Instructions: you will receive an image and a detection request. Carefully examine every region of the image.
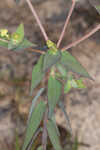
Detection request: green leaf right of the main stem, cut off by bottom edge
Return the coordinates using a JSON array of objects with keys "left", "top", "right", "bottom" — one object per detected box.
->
[{"left": 47, "top": 120, "right": 62, "bottom": 150}]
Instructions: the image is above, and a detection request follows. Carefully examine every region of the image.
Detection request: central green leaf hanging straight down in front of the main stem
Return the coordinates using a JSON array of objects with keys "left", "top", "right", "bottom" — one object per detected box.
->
[{"left": 48, "top": 76, "right": 61, "bottom": 118}]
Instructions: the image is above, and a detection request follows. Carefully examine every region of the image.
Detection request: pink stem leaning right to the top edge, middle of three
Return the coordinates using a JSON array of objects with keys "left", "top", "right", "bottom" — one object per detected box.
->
[{"left": 57, "top": 0, "right": 76, "bottom": 48}]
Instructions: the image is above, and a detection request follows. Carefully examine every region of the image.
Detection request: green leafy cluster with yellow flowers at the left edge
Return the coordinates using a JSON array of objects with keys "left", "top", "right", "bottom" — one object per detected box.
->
[{"left": 0, "top": 24, "right": 36, "bottom": 50}]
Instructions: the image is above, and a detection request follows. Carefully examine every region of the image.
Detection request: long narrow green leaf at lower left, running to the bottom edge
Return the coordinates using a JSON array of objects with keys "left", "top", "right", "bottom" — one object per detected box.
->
[{"left": 22, "top": 101, "right": 46, "bottom": 150}]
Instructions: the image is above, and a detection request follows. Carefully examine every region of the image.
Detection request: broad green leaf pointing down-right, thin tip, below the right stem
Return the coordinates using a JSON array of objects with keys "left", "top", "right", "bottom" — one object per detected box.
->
[{"left": 61, "top": 51, "right": 91, "bottom": 78}]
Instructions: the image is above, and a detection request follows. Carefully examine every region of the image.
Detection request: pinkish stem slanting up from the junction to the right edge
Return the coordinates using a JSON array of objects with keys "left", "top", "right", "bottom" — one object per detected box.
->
[{"left": 61, "top": 24, "right": 100, "bottom": 51}]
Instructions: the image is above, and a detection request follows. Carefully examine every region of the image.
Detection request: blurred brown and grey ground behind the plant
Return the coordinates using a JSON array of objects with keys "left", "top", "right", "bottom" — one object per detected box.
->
[{"left": 0, "top": 0, "right": 100, "bottom": 150}]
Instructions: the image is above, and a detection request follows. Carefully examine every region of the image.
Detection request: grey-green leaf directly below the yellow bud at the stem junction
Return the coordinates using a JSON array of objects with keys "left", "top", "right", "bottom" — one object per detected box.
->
[{"left": 43, "top": 50, "right": 61, "bottom": 71}]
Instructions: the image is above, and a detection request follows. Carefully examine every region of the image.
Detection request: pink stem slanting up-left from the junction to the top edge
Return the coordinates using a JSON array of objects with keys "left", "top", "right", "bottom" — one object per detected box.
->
[{"left": 26, "top": 0, "right": 48, "bottom": 41}]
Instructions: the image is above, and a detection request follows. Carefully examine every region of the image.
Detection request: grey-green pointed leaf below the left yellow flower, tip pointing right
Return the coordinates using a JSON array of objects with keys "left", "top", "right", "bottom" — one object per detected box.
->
[{"left": 13, "top": 39, "right": 36, "bottom": 51}]
